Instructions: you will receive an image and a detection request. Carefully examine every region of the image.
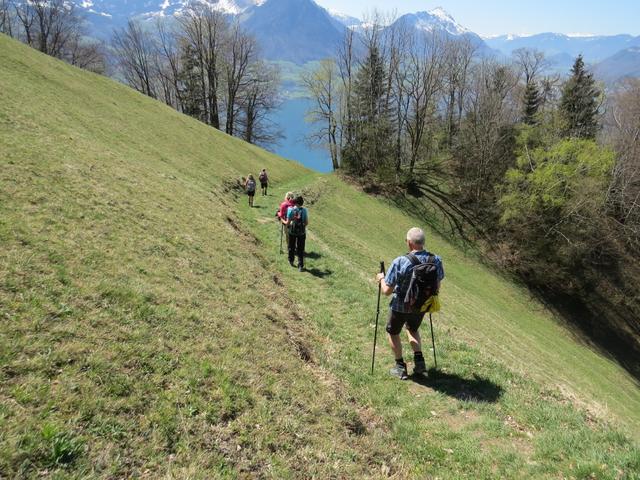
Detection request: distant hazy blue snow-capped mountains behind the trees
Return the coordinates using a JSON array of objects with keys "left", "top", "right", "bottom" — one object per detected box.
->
[{"left": 77, "top": 0, "right": 640, "bottom": 82}]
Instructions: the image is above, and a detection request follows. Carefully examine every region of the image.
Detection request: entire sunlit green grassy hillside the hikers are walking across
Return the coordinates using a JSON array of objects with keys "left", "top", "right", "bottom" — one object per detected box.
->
[{"left": 0, "top": 36, "right": 640, "bottom": 479}]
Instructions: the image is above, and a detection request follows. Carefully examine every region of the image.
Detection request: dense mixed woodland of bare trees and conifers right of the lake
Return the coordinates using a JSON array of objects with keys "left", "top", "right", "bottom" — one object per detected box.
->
[{"left": 304, "top": 18, "right": 640, "bottom": 376}]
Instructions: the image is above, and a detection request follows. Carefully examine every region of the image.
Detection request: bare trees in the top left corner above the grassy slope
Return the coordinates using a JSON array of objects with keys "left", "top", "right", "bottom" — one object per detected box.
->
[{"left": 0, "top": 0, "right": 106, "bottom": 74}]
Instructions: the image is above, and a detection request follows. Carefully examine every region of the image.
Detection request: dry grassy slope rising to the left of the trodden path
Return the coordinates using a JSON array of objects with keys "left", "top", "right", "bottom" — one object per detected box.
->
[{"left": 0, "top": 32, "right": 384, "bottom": 478}]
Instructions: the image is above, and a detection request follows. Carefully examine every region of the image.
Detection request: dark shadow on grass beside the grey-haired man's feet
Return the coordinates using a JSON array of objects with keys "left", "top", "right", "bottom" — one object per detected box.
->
[{"left": 409, "top": 369, "right": 502, "bottom": 403}]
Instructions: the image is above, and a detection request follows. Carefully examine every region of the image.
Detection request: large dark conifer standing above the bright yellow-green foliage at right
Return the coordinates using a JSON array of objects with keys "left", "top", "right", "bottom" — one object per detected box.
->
[{"left": 560, "top": 55, "right": 600, "bottom": 139}]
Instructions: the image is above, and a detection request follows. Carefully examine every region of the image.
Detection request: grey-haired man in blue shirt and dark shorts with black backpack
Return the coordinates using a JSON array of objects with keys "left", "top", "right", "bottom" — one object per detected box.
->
[{"left": 376, "top": 228, "right": 444, "bottom": 380}]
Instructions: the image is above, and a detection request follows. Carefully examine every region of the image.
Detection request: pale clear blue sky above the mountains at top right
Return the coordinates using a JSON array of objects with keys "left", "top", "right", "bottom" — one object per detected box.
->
[{"left": 316, "top": 0, "right": 640, "bottom": 35}]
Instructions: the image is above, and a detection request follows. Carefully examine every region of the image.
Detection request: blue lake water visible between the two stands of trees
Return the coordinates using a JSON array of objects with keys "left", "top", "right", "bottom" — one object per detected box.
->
[{"left": 273, "top": 98, "right": 332, "bottom": 173}]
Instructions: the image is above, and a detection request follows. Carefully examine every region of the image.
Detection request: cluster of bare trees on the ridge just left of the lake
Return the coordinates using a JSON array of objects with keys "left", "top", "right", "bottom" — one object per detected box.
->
[{"left": 111, "top": 2, "right": 280, "bottom": 146}]
